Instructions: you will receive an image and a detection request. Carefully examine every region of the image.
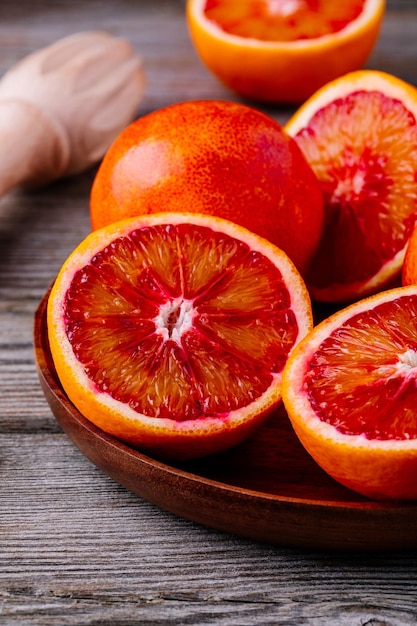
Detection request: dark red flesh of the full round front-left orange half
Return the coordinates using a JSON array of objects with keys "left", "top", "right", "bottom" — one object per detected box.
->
[{"left": 64, "top": 224, "right": 298, "bottom": 420}]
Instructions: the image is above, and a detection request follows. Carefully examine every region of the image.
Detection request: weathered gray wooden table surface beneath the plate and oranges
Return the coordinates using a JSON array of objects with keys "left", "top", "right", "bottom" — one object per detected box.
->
[{"left": 0, "top": 0, "right": 417, "bottom": 626}]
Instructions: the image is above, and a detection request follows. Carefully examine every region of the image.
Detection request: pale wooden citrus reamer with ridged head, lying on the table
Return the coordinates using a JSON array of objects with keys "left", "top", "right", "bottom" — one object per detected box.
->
[{"left": 0, "top": 31, "right": 145, "bottom": 196}]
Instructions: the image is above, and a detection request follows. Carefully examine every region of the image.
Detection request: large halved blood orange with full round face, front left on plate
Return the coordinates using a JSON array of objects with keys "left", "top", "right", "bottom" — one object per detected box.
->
[{"left": 48, "top": 213, "right": 312, "bottom": 458}]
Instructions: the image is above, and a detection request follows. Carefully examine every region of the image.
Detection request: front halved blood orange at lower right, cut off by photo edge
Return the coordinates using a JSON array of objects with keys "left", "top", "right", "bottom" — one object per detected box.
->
[{"left": 282, "top": 286, "right": 417, "bottom": 500}]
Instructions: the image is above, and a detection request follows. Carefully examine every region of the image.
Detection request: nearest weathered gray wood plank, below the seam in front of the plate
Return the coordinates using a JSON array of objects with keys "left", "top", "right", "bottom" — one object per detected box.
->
[{"left": 0, "top": 434, "right": 417, "bottom": 625}]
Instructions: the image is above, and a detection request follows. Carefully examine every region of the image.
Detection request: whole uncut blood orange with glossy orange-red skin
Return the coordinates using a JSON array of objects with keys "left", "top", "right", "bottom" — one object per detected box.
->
[{"left": 90, "top": 101, "right": 323, "bottom": 271}]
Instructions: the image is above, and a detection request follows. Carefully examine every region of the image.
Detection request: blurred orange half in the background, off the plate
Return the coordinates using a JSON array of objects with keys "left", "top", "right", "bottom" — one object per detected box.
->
[{"left": 187, "top": 0, "right": 385, "bottom": 102}]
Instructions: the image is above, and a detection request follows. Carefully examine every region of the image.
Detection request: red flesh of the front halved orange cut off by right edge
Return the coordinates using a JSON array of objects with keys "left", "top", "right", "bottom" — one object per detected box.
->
[{"left": 305, "top": 295, "right": 417, "bottom": 440}]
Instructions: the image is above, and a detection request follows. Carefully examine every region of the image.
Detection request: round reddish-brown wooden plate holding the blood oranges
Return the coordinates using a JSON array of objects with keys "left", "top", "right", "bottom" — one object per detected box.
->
[{"left": 34, "top": 294, "right": 417, "bottom": 551}]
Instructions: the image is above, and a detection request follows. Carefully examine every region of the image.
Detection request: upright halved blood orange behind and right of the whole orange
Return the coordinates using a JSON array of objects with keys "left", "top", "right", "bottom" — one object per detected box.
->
[{"left": 286, "top": 70, "right": 417, "bottom": 302}]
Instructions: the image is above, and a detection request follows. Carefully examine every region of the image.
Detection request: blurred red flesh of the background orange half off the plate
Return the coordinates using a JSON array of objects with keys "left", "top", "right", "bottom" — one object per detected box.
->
[{"left": 204, "top": 0, "right": 365, "bottom": 41}]
